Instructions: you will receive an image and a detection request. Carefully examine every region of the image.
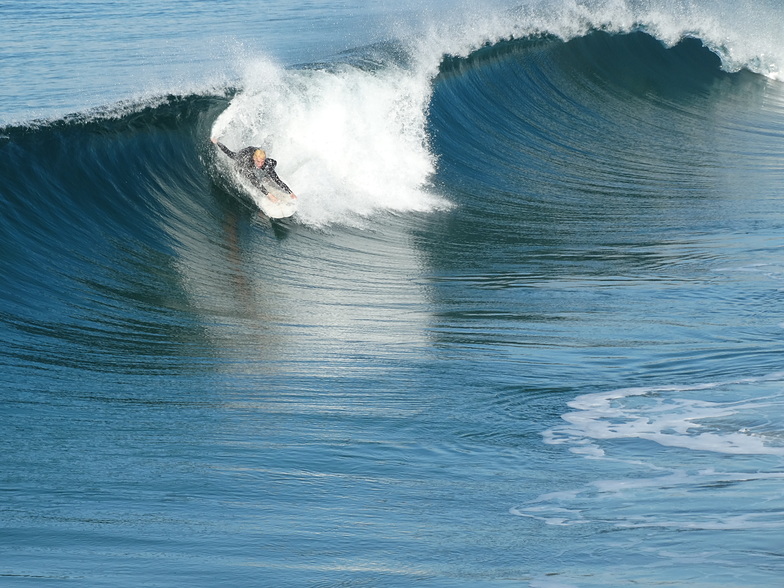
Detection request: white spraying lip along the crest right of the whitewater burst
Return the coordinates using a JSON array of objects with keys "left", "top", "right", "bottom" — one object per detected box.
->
[{"left": 415, "top": 0, "right": 784, "bottom": 80}]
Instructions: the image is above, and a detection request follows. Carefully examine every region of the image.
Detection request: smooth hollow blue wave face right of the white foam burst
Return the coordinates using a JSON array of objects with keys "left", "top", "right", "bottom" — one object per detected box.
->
[{"left": 431, "top": 32, "right": 778, "bottom": 207}]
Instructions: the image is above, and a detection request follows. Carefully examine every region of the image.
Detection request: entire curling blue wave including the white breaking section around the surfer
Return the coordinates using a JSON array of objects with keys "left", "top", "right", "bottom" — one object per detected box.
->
[{"left": 0, "top": 18, "right": 784, "bottom": 374}]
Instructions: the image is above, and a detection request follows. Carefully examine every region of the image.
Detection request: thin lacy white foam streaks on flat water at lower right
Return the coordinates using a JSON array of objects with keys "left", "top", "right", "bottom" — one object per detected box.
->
[{"left": 510, "top": 373, "right": 784, "bottom": 531}]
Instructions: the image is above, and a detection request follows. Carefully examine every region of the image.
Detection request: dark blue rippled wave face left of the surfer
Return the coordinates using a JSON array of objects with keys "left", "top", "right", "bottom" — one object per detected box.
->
[{"left": 0, "top": 96, "right": 230, "bottom": 371}]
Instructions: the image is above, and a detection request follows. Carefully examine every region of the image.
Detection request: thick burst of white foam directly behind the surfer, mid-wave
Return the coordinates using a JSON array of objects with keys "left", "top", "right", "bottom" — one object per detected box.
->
[{"left": 213, "top": 55, "right": 447, "bottom": 225}]
